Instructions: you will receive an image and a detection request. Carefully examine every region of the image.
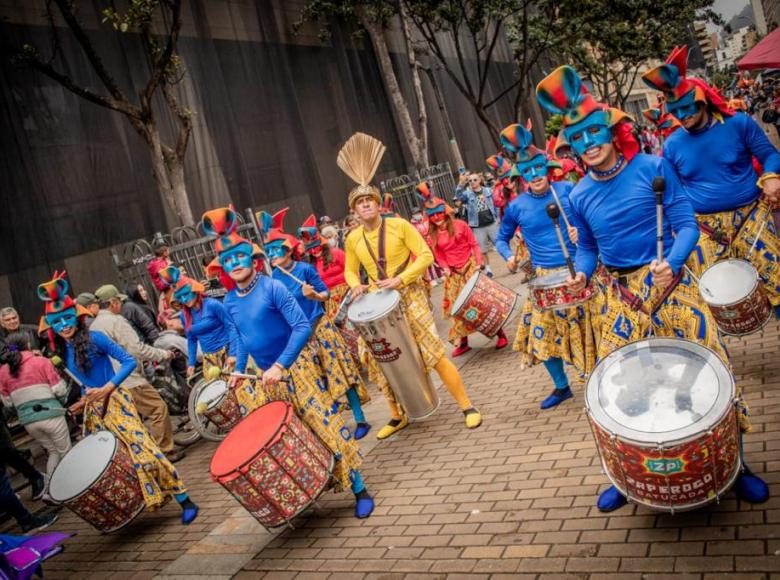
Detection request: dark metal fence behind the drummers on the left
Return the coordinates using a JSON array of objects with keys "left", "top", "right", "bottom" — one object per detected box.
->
[{"left": 109, "top": 210, "right": 262, "bottom": 310}]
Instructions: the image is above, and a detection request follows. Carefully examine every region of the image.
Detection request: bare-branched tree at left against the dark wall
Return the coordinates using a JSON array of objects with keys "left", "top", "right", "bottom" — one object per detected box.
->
[{"left": 14, "top": 0, "right": 194, "bottom": 225}]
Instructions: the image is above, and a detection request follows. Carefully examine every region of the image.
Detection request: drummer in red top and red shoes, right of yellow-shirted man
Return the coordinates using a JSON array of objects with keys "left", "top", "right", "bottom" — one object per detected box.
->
[{"left": 416, "top": 182, "right": 509, "bottom": 358}]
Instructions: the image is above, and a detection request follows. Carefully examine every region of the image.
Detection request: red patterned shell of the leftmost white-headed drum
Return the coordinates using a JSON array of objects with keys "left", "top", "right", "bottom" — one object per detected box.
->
[{"left": 51, "top": 435, "right": 146, "bottom": 533}]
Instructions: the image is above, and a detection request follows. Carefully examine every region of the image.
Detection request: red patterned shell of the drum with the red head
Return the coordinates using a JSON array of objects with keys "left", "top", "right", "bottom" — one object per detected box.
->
[{"left": 212, "top": 403, "right": 334, "bottom": 528}]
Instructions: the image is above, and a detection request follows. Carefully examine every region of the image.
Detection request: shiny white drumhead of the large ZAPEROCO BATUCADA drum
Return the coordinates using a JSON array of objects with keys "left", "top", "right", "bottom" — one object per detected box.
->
[{"left": 585, "top": 338, "right": 735, "bottom": 444}]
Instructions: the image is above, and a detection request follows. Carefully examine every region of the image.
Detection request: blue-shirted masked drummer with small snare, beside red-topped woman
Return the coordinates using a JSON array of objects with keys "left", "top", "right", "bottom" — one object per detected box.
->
[{"left": 496, "top": 124, "right": 596, "bottom": 409}]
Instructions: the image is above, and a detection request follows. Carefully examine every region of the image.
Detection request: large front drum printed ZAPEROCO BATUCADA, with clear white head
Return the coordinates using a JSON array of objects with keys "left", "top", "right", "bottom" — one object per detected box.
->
[{"left": 585, "top": 338, "right": 741, "bottom": 512}]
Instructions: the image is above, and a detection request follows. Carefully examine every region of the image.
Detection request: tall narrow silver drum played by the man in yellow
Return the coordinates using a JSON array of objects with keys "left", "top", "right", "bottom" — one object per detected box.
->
[{"left": 348, "top": 290, "right": 439, "bottom": 419}]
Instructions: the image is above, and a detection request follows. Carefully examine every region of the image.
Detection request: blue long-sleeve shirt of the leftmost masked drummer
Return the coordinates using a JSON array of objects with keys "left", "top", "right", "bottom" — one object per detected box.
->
[{"left": 65, "top": 331, "right": 137, "bottom": 394}]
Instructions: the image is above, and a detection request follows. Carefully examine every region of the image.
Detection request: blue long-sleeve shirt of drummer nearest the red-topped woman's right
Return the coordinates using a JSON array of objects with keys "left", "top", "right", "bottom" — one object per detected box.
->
[{"left": 496, "top": 181, "right": 576, "bottom": 268}]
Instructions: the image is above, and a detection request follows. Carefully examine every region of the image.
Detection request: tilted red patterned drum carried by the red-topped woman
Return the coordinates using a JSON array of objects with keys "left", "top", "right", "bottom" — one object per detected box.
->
[{"left": 451, "top": 272, "right": 517, "bottom": 337}]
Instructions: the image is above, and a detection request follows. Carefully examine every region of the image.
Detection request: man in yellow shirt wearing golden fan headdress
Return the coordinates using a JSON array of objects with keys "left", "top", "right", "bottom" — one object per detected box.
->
[{"left": 339, "top": 133, "right": 482, "bottom": 436}]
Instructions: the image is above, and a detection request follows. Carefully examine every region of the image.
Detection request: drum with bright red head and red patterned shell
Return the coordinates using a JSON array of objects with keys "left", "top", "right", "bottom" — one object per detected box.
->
[{"left": 210, "top": 401, "right": 334, "bottom": 528}]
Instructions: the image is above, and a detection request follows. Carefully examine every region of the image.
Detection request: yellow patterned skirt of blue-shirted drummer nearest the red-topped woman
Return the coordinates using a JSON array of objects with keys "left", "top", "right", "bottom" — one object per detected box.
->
[{"left": 513, "top": 267, "right": 596, "bottom": 375}]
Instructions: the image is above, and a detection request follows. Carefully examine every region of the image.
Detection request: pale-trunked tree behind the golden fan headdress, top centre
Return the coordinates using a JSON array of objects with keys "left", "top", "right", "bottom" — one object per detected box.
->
[{"left": 295, "top": 0, "right": 431, "bottom": 169}]
